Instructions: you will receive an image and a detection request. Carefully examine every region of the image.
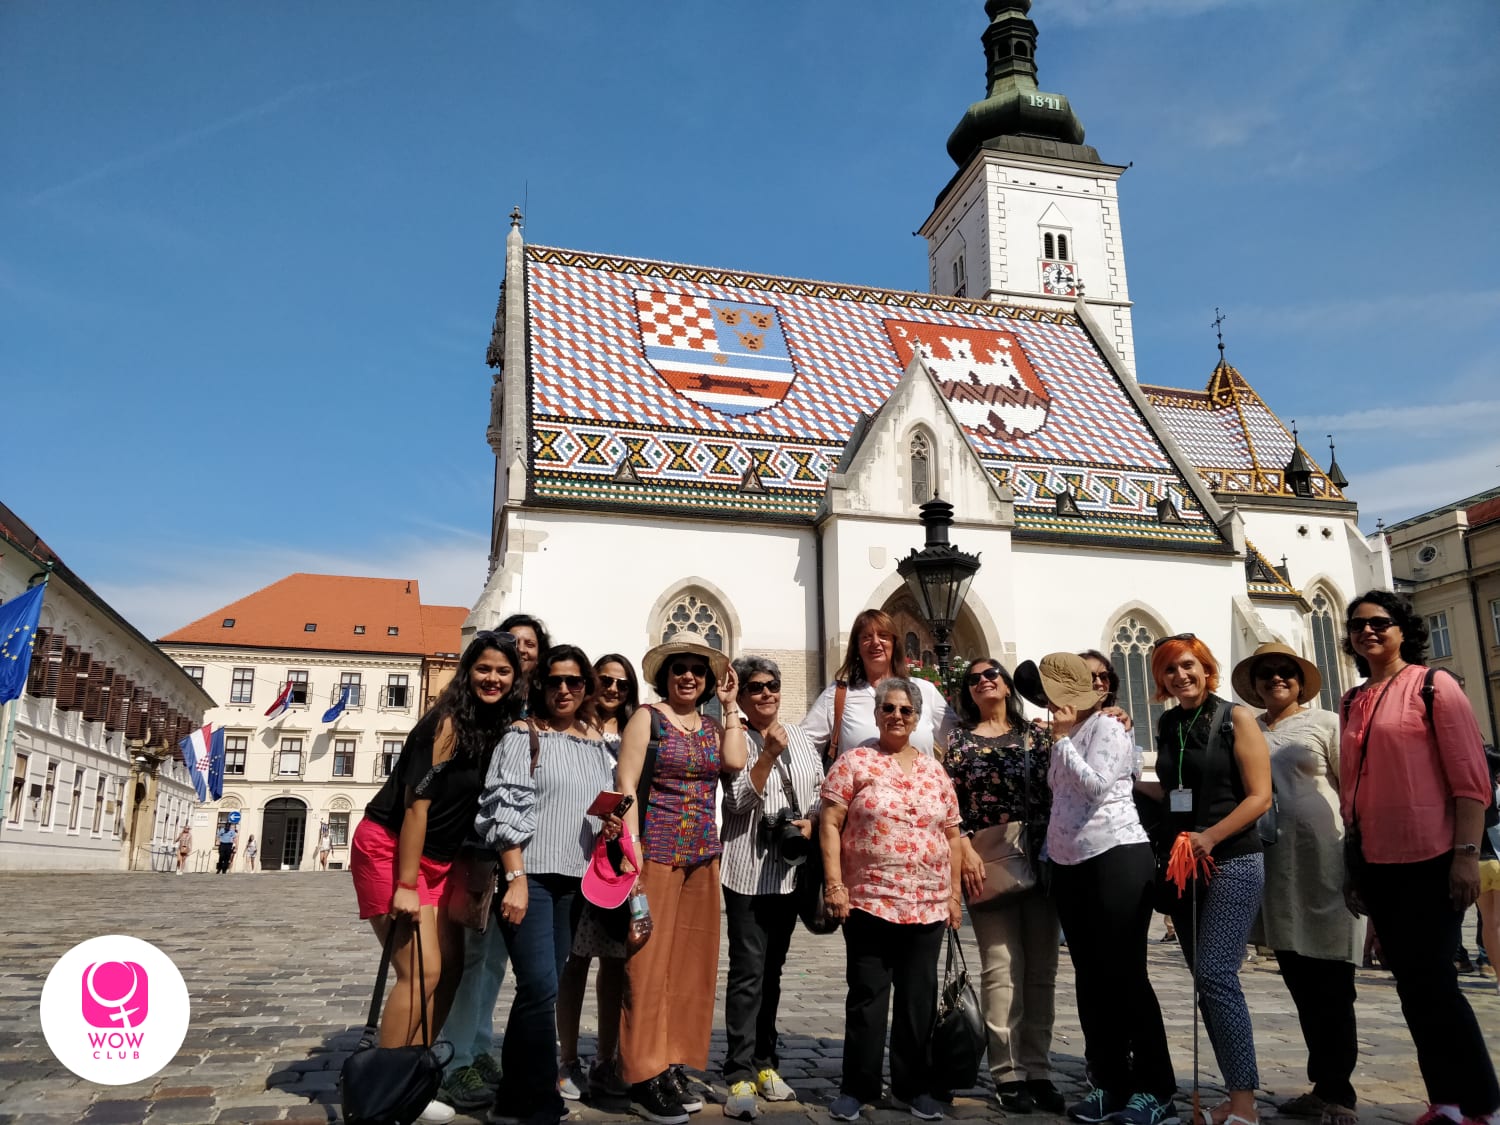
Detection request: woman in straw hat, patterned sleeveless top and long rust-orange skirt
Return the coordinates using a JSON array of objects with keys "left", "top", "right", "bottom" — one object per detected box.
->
[{"left": 618, "top": 638, "right": 747, "bottom": 1125}]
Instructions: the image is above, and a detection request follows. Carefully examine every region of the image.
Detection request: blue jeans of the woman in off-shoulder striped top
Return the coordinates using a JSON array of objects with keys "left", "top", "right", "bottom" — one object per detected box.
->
[{"left": 495, "top": 875, "right": 582, "bottom": 1121}]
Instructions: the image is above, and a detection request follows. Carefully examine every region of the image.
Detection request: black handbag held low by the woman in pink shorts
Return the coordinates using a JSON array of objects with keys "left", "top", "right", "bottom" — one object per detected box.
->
[{"left": 339, "top": 920, "right": 453, "bottom": 1125}]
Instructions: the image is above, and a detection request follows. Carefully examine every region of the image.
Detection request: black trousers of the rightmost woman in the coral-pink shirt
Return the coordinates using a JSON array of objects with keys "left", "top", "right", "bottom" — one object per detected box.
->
[{"left": 1359, "top": 855, "right": 1500, "bottom": 1119}]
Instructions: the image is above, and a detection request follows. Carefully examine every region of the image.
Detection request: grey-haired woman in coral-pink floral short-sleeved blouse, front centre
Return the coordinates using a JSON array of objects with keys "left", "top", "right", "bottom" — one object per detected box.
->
[{"left": 821, "top": 677, "right": 963, "bottom": 1121}]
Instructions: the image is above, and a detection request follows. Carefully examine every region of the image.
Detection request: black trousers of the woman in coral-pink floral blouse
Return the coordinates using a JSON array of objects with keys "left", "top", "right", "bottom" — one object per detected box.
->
[{"left": 839, "top": 911, "right": 947, "bottom": 1101}]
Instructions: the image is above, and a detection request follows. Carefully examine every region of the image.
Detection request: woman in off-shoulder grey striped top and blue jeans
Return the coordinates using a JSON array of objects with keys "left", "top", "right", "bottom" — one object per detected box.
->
[{"left": 477, "top": 645, "right": 615, "bottom": 1122}]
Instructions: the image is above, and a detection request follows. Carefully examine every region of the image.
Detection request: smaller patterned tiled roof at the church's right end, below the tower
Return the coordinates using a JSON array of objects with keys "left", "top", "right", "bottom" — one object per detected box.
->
[{"left": 1142, "top": 360, "right": 1344, "bottom": 501}]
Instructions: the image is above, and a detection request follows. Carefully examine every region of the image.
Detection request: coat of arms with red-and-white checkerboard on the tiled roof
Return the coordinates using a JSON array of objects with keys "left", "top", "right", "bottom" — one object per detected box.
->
[{"left": 636, "top": 290, "right": 797, "bottom": 414}]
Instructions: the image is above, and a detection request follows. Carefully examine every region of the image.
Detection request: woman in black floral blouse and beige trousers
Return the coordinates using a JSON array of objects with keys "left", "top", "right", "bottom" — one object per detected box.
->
[{"left": 944, "top": 657, "right": 1064, "bottom": 1113}]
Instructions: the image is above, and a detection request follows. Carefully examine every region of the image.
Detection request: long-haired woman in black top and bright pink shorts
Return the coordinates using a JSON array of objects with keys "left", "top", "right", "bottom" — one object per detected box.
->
[{"left": 350, "top": 633, "right": 521, "bottom": 1047}]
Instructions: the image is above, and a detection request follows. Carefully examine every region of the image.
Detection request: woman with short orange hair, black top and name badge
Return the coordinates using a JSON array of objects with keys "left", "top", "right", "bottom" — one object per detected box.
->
[{"left": 1142, "top": 633, "right": 1271, "bottom": 1125}]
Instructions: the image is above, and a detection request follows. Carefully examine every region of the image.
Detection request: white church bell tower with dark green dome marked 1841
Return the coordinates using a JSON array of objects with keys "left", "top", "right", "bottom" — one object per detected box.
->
[{"left": 920, "top": 0, "right": 1136, "bottom": 375}]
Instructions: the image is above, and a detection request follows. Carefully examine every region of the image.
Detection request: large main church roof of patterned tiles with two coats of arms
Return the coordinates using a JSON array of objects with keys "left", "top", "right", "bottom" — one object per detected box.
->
[{"left": 527, "top": 246, "right": 1226, "bottom": 551}]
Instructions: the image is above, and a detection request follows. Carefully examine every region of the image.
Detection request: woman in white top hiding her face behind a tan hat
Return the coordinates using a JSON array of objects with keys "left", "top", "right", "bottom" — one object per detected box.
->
[{"left": 1016, "top": 653, "right": 1178, "bottom": 1125}]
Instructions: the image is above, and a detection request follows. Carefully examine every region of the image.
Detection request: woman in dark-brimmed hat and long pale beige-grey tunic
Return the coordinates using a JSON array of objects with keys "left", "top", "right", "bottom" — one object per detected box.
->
[{"left": 1230, "top": 644, "right": 1361, "bottom": 1125}]
